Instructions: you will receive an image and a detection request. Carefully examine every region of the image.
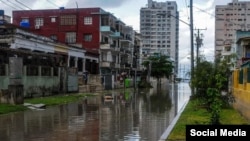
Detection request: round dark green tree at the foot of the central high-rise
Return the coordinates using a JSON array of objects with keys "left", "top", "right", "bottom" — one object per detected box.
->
[{"left": 142, "top": 55, "right": 174, "bottom": 83}]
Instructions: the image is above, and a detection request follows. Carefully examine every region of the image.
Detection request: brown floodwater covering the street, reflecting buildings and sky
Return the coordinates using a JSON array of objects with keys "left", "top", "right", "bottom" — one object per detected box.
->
[{"left": 0, "top": 83, "right": 190, "bottom": 141}]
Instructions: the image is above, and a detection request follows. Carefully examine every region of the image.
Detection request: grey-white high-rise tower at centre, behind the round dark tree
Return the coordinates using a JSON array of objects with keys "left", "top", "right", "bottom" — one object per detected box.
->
[{"left": 140, "top": 0, "right": 179, "bottom": 73}]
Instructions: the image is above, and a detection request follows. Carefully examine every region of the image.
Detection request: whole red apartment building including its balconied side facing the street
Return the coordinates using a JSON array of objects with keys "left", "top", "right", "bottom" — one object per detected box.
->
[{"left": 13, "top": 7, "right": 140, "bottom": 87}]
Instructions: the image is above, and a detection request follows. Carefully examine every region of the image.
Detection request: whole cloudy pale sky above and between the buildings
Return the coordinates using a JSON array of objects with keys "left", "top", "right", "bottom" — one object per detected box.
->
[{"left": 0, "top": 0, "right": 243, "bottom": 75}]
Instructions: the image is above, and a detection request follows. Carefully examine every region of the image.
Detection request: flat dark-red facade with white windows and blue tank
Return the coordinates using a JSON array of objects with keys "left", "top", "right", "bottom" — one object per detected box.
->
[{"left": 13, "top": 8, "right": 105, "bottom": 74}]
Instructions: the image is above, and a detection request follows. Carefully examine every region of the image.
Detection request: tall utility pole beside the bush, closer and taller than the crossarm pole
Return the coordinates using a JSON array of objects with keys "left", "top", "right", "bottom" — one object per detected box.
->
[{"left": 190, "top": 0, "right": 194, "bottom": 95}]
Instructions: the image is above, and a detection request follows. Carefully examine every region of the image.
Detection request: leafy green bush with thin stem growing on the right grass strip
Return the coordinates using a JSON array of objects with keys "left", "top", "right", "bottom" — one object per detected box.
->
[{"left": 191, "top": 55, "right": 235, "bottom": 124}]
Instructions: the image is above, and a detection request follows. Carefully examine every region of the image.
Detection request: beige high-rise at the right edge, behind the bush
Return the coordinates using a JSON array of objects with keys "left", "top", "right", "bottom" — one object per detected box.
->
[{"left": 214, "top": 0, "right": 250, "bottom": 57}]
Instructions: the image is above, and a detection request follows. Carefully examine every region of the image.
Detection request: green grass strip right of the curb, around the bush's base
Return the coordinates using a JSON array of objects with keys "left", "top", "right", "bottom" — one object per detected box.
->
[{"left": 166, "top": 100, "right": 249, "bottom": 141}]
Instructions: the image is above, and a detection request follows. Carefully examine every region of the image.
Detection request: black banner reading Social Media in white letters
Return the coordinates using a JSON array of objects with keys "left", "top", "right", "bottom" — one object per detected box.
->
[{"left": 186, "top": 125, "right": 250, "bottom": 141}]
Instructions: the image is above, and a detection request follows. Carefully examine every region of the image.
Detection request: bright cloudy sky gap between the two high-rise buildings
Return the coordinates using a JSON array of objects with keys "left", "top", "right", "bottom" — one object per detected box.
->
[{"left": 179, "top": 0, "right": 215, "bottom": 64}]
